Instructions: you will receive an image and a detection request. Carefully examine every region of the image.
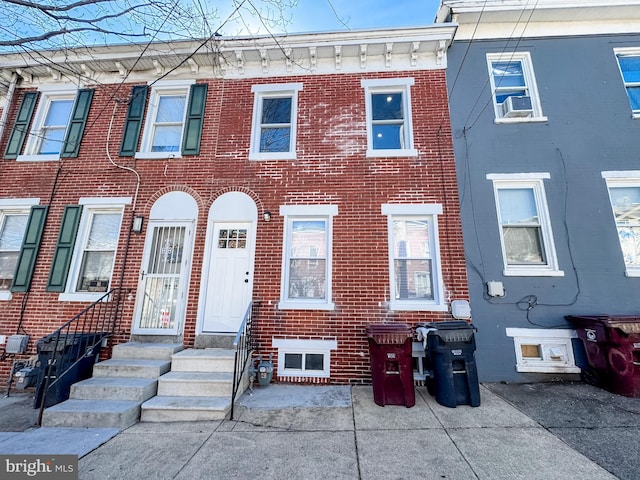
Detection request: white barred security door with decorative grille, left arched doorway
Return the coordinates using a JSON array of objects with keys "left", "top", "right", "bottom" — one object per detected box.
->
[{"left": 133, "top": 220, "right": 193, "bottom": 335}]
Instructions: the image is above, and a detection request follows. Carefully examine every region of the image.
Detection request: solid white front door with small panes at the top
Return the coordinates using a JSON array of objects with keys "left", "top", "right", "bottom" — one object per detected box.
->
[{"left": 202, "top": 223, "right": 253, "bottom": 333}]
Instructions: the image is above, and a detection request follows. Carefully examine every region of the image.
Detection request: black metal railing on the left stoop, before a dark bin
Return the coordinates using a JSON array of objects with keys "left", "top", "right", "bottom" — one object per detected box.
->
[{"left": 35, "top": 288, "right": 124, "bottom": 425}]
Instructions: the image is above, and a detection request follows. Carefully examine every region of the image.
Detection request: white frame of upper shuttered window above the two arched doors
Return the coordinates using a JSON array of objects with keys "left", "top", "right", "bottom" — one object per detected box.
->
[{"left": 135, "top": 80, "right": 195, "bottom": 159}]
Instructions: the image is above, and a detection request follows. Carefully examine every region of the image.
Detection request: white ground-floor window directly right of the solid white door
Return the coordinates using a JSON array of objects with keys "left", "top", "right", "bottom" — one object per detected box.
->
[{"left": 280, "top": 205, "right": 338, "bottom": 310}]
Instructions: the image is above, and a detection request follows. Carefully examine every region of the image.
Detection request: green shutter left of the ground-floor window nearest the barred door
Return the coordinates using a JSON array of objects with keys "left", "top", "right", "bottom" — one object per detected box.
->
[{"left": 47, "top": 205, "right": 82, "bottom": 292}]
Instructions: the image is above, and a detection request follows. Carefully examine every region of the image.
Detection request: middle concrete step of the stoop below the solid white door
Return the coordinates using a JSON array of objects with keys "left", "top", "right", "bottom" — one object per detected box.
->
[{"left": 158, "top": 371, "right": 233, "bottom": 397}]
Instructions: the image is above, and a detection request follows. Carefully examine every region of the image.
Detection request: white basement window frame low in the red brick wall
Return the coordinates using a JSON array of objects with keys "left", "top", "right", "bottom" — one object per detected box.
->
[{"left": 271, "top": 338, "right": 338, "bottom": 378}]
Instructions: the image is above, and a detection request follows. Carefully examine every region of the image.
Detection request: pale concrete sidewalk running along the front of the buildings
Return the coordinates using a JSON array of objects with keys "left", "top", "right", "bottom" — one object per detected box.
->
[{"left": 0, "top": 384, "right": 640, "bottom": 480}]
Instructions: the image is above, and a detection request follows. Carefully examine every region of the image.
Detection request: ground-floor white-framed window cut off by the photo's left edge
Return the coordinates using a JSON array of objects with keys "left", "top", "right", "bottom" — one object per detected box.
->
[{"left": 0, "top": 198, "right": 39, "bottom": 300}]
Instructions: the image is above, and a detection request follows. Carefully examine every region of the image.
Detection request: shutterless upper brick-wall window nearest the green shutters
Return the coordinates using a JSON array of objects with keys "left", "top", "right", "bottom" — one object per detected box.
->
[{"left": 249, "top": 83, "right": 302, "bottom": 160}]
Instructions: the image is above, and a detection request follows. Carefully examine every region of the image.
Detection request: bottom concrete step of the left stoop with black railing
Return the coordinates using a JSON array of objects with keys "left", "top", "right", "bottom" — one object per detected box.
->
[{"left": 42, "top": 399, "right": 140, "bottom": 429}]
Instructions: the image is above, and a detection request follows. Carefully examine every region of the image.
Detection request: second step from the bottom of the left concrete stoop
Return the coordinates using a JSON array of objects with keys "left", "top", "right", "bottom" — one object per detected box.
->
[{"left": 70, "top": 377, "right": 158, "bottom": 402}]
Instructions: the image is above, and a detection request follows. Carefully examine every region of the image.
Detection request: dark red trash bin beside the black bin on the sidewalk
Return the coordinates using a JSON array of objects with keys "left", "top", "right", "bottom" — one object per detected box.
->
[{"left": 367, "top": 323, "right": 416, "bottom": 407}]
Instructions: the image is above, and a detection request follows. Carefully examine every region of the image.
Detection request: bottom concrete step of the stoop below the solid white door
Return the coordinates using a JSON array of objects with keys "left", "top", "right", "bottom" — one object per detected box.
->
[{"left": 140, "top": 396, "right": 231, "bottom": 422}]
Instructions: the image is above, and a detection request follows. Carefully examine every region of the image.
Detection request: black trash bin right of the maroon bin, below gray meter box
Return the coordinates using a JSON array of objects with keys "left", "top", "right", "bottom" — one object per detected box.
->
[{"left": 423, "top": 321, "right": 480, "bottom": 408}]
